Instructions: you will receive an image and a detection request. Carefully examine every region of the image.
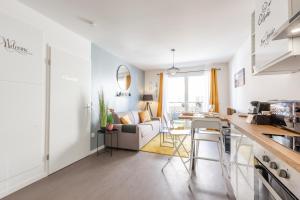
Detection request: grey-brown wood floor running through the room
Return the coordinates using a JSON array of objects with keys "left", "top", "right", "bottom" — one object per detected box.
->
[{"left": 4, "top": 144, "right": 236, "bottom": 200}]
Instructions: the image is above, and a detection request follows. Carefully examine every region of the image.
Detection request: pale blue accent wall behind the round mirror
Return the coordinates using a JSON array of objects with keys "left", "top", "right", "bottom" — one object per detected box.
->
[{"left": 91, "top": 44, "right": 145, "bottom": 150}]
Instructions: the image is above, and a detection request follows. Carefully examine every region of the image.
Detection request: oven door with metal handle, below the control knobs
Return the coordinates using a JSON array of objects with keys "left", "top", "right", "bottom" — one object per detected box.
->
[{"left": 254, "top": 157, "right": 298, "bottom": 200}]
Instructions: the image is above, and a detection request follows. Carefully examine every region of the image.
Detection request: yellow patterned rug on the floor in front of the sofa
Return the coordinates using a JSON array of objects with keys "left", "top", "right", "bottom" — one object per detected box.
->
[{"left": 141, "top": 134, "right": 191, "bottom": 157}]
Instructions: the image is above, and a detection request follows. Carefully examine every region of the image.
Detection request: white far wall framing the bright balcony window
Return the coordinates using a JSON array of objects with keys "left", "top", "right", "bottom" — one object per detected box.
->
[{"left": 145, "top": 64, "right": 230, "bottom": 115}]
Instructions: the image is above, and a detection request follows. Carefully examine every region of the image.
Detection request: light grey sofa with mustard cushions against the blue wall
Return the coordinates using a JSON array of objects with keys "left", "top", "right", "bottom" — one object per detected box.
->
[{"left": 105, "top": 111, "right": 160, "bottom": 150}]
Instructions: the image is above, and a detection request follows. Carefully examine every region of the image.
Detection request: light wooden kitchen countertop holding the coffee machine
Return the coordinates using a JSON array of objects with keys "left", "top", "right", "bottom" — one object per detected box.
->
[{"left": 227, "top": 114, "right": 300, "bottom": 172}]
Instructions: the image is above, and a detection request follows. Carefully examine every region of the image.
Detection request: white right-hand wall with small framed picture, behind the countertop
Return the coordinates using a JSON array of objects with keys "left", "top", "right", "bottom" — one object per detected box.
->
[{"left": 229, "top": 37, "right": 300, "bottom": 112}]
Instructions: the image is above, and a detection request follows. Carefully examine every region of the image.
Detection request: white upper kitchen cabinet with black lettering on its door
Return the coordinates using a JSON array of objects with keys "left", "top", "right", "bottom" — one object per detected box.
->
[{"left": 251, "top": 0, "right": 300, "bottom": 75}]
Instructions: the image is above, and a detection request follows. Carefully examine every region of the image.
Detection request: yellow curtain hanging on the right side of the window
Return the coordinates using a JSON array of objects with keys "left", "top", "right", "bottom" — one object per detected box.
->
[{"left": 209, "top": 68, "right": 220, "bottom": 112}]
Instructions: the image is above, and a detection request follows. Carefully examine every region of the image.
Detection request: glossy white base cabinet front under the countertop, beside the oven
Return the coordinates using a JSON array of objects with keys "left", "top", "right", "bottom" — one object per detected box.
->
[{"left": 229, "top": 125, "right": 254, "bottom": 200}]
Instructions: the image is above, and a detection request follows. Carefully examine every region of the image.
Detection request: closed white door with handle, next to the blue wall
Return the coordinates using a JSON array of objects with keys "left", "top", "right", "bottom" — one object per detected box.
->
[{"left": 49, "top": 47, "right": 91, "bottom": 174}]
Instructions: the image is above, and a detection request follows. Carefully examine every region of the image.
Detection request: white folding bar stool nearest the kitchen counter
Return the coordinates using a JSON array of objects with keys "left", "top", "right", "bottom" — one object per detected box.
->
[{"left": 189, "top": 118, "right": 224, "bottom": 176}]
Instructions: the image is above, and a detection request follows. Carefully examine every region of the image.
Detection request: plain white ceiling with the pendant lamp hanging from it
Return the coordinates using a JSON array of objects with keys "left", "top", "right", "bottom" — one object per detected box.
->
[{"left": 20, "top": 0, "right": 254, "bottom": 70}]
